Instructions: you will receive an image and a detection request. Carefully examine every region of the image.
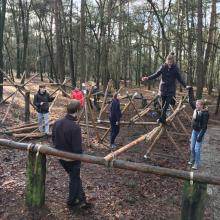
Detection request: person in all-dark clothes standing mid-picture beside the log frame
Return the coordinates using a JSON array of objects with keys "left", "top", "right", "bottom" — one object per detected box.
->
[{"left": 109, "top": 93, "right": 122, "bottom": 148}]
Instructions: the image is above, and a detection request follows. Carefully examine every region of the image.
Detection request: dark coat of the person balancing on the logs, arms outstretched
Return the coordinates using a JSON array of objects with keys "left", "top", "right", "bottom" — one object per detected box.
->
[{"left": 148, "top": 64, "right": 186, "bottom": 96}]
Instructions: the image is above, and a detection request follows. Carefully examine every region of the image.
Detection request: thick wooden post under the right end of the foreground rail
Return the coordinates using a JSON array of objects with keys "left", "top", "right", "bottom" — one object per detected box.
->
[{"left": 181, "top": 181, "right": 207, "bottom": 220}]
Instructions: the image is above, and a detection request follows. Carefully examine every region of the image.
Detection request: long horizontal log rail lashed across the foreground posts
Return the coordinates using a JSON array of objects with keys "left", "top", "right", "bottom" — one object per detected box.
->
[{"left": 0, "top": 139, "right": 220, "bottom": 185}]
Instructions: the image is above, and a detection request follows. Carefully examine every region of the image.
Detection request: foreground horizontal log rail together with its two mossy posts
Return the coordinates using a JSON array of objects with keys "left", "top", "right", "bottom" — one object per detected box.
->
[{"left": 0, "top": 139, "right": 217, "bottom": 220}]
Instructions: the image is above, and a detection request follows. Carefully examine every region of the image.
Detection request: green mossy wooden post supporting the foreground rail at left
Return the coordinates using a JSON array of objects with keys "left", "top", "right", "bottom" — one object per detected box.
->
[{"left": 25, "top": 151, "right": 46, "bottom": 208}]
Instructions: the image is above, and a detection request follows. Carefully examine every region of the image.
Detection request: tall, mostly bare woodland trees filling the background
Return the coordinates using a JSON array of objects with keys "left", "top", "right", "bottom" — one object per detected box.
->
[{"left": 0, "top": 0, "right": 220, "bottom": 98}]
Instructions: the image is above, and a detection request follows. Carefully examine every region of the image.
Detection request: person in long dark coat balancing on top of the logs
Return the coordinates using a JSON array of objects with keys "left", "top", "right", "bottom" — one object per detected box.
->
[{"left": 142, "top": 53, "right": 189, "bottom": 123}]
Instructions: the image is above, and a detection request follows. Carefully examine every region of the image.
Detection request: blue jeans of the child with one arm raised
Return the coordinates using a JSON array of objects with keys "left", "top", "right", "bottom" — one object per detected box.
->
[{"left": 191, "top": 130, "right": 204, "bottom": 165}]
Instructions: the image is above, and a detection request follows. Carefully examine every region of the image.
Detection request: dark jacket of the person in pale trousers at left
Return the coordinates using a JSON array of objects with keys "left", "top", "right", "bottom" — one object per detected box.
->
[{"left": 34, "top": 90, "right": 54, "bottom": 113}]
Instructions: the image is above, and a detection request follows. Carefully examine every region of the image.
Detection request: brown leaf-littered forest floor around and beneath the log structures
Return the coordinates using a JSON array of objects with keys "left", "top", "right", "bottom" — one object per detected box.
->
[{"left": 0, "top": 78, "right": 220, "bottom": 220}]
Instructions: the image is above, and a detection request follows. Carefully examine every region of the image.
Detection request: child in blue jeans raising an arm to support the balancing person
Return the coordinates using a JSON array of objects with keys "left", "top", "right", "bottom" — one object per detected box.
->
[{"left": 188, "top": 87, "right": 209, "bottom": 170}]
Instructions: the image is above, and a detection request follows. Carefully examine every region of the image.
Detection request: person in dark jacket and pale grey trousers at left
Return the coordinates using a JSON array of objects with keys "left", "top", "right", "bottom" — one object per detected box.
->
[{"left": 34, "top": 84, "right": 54, "bottom": 134}]
